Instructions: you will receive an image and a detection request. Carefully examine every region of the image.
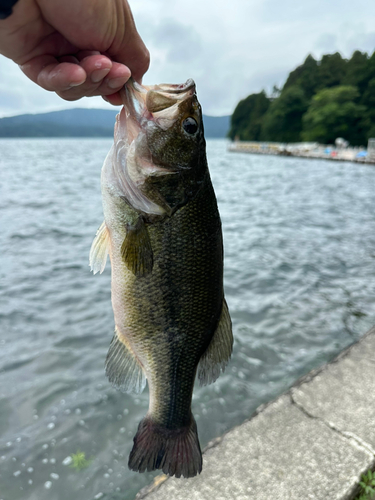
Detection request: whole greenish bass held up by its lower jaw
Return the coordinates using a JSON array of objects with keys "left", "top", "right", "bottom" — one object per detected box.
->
[{"left": 90, "top": 79, "right": 233, "bottom": 478}]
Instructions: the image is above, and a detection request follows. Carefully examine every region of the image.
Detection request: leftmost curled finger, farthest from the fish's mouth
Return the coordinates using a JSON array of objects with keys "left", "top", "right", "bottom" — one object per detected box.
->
[{"left": 20, "top": 55, "right": 87, "bottom": 92}]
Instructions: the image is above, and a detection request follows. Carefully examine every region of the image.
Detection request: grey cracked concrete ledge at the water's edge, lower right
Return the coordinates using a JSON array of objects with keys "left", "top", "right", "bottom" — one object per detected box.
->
[{"left": 136, "top": 328, "right": 375, "bottom": 500}]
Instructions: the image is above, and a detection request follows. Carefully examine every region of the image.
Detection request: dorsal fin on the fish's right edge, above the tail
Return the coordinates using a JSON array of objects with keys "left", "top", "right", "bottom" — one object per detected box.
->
[{"left": 198, "top": 299, "right": 233, "bottom": 385}]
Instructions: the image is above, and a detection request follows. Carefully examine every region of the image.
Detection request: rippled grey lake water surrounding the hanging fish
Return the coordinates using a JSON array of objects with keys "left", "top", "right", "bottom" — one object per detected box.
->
[{"left": 0, "top": 139, "right": 375, "bottom": 500}]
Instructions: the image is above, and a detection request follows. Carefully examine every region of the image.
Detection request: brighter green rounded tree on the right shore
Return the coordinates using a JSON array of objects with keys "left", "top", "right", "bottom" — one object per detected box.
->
[{"left": 302, "top": 85, "right": 366, "bottom": 145}]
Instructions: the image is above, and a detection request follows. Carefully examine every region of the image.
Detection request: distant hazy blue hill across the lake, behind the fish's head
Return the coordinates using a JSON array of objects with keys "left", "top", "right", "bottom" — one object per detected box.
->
[{"left": 0, "top": 108, "right": 230, "bottom": 138}]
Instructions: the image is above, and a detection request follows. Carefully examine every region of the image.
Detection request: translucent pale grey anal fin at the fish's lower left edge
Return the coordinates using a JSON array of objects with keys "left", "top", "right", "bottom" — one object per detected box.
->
[{"left": 105, "top": 328, "right": 146, "bottom": 393}]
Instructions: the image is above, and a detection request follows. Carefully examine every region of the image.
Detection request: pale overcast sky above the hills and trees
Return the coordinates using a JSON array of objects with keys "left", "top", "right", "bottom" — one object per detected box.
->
[{"left": 0, "top": 0, "right": 375, "bottom": 116}]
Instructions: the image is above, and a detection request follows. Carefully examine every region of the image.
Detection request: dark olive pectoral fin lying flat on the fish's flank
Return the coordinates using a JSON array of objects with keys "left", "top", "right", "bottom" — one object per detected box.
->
[{"left": 121, "top": 217, "right": 153, "bottom": 276}]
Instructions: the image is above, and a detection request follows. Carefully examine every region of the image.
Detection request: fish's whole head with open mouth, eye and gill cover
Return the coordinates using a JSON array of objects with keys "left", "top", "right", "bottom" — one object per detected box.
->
[{"left": 104, "top": 80, "right": 206, "bottom": 216}]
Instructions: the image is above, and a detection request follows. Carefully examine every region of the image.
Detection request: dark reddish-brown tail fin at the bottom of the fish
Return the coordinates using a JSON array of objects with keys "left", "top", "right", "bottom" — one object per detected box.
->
[{"left": 128, "top": 415, "right": 202, "bottom": 477}]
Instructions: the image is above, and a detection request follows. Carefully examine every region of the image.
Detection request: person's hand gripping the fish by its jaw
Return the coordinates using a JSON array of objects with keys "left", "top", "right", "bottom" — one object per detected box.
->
[{"left": 0, "top": 0, "right": 149, "bottom": 104}]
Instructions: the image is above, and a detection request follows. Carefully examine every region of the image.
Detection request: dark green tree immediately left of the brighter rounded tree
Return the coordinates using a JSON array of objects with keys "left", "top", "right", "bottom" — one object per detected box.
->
[{"left": 261, "top": 85, "right": 309, "bottom": 142}]
